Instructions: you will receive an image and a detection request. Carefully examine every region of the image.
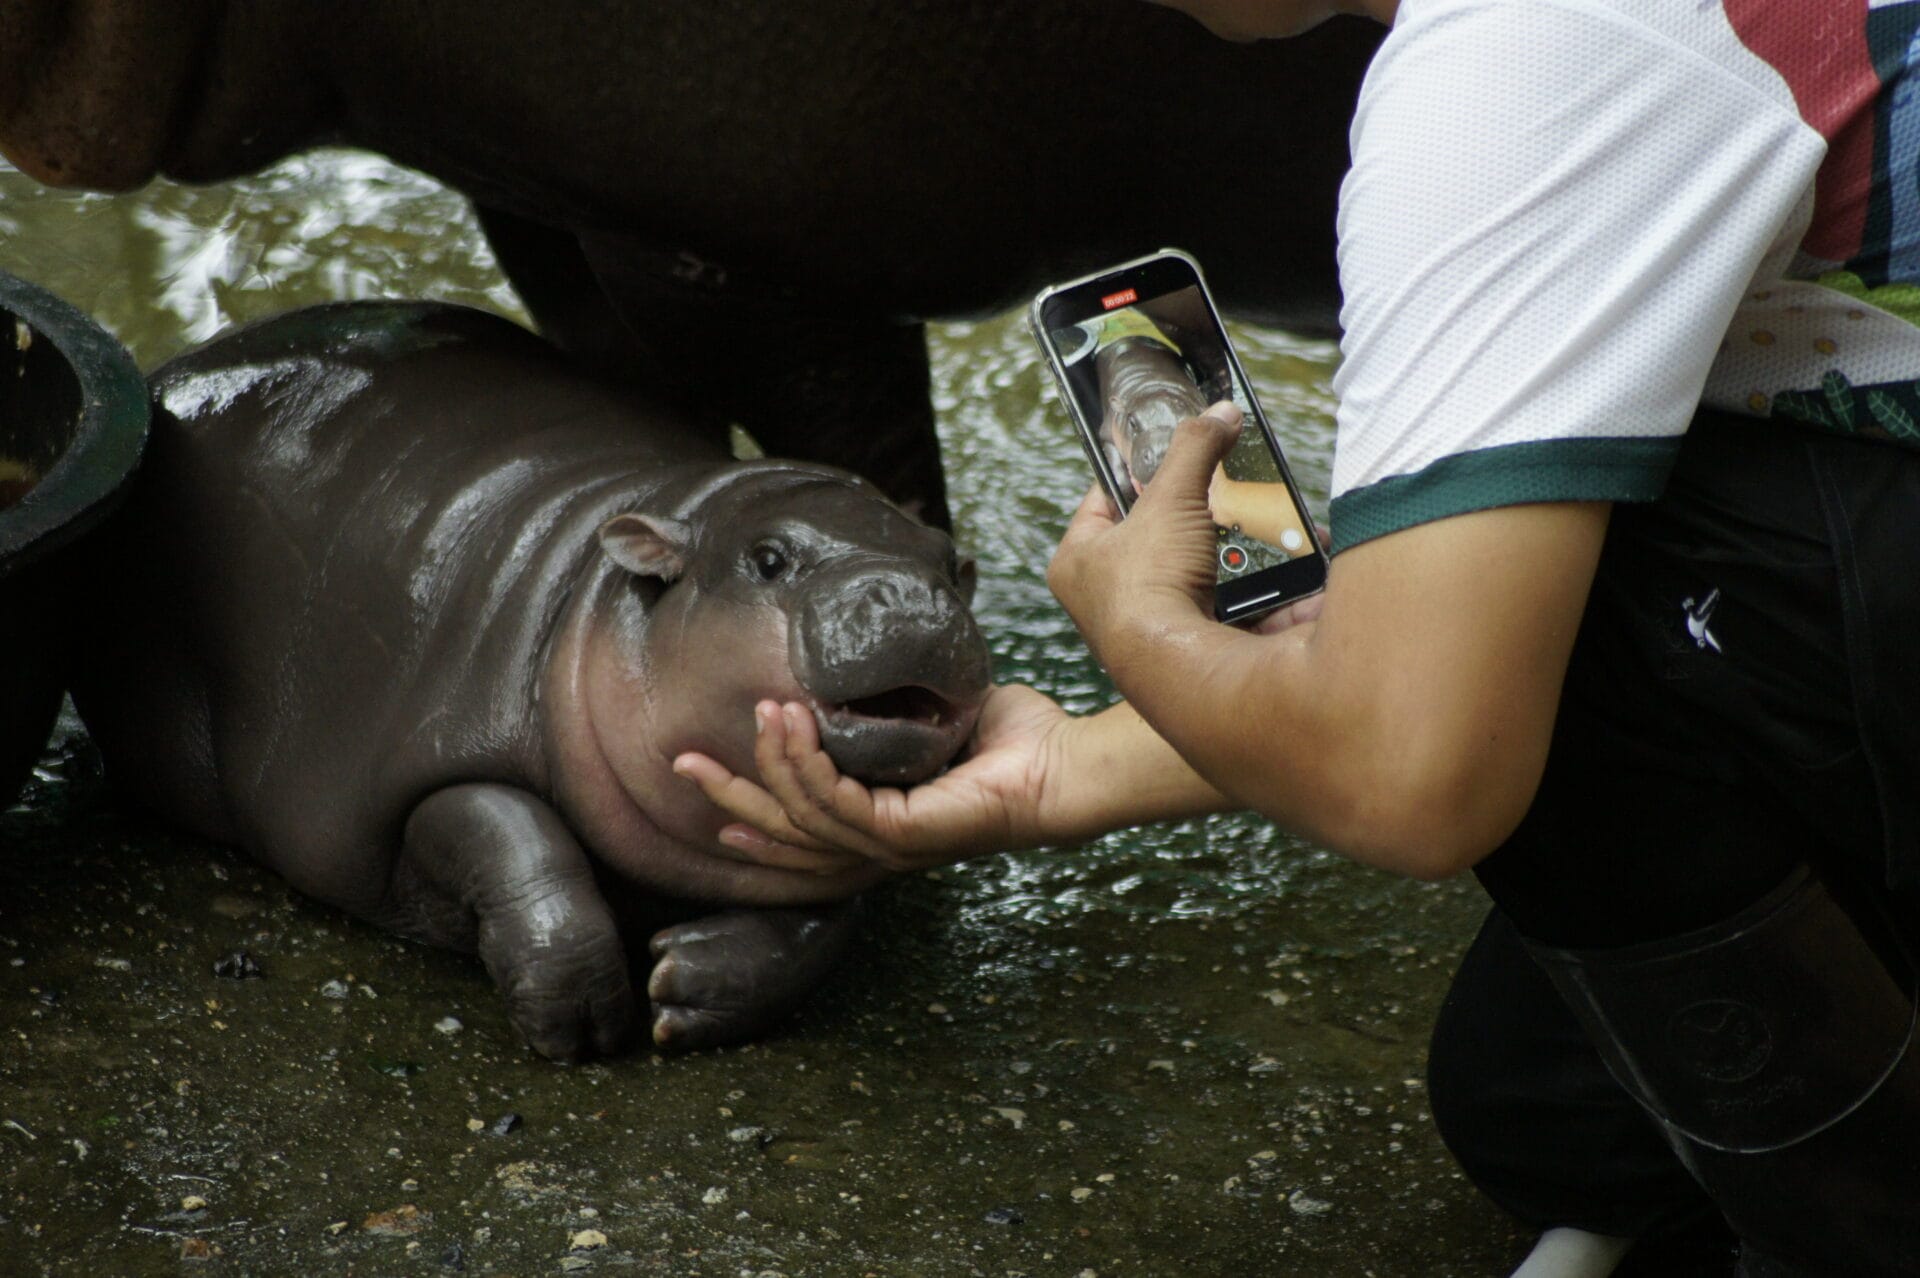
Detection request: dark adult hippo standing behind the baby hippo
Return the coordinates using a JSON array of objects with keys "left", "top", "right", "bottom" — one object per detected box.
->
[{"left": 0, "top": 0, "right": 1380, "bottom": 524}]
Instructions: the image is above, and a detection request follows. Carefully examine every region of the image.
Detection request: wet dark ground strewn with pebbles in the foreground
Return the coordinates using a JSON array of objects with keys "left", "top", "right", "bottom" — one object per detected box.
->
[{"left": 0, "top": 706, "right": 1519, "bottom": 1278}]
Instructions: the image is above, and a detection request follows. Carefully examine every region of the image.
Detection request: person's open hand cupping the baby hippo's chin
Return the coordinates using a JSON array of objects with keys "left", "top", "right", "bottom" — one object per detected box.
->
[{"left": 674, "top": 683, "right": 1071, "bottom": 871}]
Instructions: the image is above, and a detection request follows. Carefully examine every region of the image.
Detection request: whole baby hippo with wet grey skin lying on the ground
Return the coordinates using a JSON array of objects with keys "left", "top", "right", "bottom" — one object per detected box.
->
[{"left": 63, "top": 303, "right": 987, "bottom": 1057}]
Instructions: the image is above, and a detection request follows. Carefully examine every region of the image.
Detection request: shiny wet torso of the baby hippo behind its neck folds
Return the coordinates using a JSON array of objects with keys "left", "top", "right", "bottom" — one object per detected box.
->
[{"left": 75, "top": 303, "right": 716, "bottom": 908}]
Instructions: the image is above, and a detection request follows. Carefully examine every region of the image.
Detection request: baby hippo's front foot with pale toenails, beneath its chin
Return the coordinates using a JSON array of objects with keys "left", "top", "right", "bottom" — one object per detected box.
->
[{"left": 647, "top": 904, "right": 856, "bottom": 1052}]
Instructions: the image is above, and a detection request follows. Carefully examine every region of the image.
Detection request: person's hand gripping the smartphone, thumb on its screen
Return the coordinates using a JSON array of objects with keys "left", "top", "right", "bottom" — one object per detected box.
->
[{"left": 1046, "top": 403, "right": 1240, "bottom": 656}]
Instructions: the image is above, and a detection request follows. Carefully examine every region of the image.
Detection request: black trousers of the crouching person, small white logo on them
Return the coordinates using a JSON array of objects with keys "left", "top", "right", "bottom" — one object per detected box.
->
[{"left": 1430, "top": 413, "right": 1920, "bottom": 1236}]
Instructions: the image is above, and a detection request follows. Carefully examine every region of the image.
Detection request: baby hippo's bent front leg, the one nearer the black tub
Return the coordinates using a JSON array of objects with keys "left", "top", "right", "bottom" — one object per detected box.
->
[{"left": 392, "top": 785, "right": 637, "bottom": 1061}]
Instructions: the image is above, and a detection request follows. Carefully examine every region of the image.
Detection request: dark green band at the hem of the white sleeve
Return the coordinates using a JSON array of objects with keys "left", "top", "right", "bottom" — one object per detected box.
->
[{"left": 1329, "top": 436, "right": 1682, "bottom": 555}]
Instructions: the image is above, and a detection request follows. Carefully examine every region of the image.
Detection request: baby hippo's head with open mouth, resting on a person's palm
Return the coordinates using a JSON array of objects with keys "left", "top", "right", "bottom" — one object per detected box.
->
[{"left": 599, "top": 462, "right": 989, "bottom": 785}]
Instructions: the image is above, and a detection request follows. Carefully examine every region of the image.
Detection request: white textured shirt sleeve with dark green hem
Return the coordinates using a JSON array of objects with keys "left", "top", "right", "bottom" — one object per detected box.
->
[{"left": 1332, "top": 0, "right": 1826, "bottom": 553}]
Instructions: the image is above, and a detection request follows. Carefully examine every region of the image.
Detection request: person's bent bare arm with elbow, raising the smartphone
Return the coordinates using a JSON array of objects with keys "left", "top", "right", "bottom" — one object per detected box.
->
[{"left": 1050, "top": 418, "right": 1611, "bottom": 877}]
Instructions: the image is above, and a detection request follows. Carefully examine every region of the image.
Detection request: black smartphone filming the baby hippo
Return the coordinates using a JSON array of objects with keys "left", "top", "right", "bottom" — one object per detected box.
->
[{"left": 1027, "top": 249, "right": 1327, "bottom": 622}]
